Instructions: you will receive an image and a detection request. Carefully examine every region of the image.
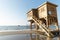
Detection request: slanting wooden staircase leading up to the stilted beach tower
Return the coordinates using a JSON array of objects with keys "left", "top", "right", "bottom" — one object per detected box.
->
[{"left": 32, "top": 17, "right": 53, "bottom": 37}]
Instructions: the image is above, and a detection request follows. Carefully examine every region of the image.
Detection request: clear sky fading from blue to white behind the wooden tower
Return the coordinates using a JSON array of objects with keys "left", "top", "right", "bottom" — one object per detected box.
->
[{"left": 0, "top": 0, "right": 60, "bottom": 25}]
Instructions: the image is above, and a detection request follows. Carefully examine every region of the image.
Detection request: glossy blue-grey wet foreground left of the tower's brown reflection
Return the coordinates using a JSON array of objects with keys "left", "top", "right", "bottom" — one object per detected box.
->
[{"left": 0, "top": 34, "right": 29, "bottom": 40}]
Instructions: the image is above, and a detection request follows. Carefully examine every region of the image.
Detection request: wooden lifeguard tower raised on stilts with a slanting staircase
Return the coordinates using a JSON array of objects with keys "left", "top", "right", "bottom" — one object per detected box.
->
[{"left": 27, "top": 2, "right": 59, "bottom": 36}]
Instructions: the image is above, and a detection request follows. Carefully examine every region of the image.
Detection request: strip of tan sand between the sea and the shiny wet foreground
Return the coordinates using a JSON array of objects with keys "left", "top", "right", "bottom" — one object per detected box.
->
[{"left": 0, "top": 29, "right": 35, "bottom": 36}]
